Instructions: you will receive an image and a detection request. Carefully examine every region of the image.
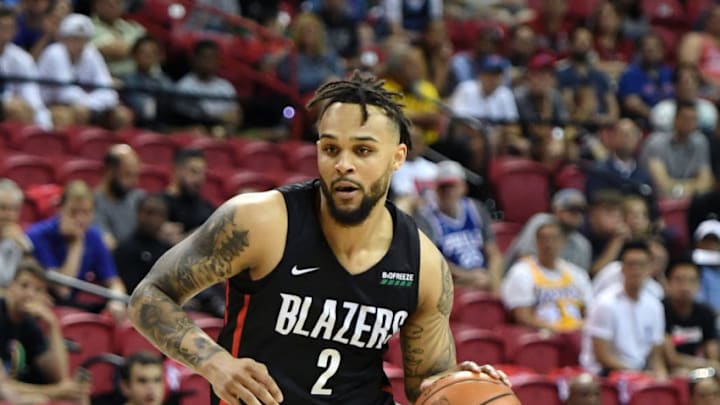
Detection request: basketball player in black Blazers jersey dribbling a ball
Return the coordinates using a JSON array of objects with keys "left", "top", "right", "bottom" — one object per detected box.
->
[{"left": 125, "top": 73, "right": 507, "bottom": 405}]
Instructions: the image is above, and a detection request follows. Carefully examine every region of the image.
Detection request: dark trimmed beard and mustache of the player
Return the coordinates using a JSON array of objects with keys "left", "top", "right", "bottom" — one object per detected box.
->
[{"left": 320, "top": 174, "right": 390, "bottom": 226}]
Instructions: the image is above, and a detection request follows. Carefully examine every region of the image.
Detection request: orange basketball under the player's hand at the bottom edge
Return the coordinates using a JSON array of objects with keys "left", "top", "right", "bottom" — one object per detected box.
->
[{"left": 415, "top": 371, "right": 521, "bottom": 405}]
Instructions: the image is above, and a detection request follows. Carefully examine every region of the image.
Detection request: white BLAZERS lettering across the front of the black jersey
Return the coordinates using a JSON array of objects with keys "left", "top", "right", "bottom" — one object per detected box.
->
[{"left": 275, "top": 294, "right": 408, "bottom": 349}]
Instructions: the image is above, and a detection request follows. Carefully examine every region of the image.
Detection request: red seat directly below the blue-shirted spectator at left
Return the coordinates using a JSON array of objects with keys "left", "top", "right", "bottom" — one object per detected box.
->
[{"left": 60, "top": 313, "right": 114, "bottom": 371}]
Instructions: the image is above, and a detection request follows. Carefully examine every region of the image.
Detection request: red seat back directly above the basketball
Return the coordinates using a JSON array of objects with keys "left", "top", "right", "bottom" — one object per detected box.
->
[{"left": 455, "top": 329, "right": 505, "bottom": 364}]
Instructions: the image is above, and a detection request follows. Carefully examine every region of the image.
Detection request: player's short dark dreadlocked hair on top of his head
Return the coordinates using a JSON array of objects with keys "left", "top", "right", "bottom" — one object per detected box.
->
[{"left": 307, "top": 70, "right": 412, "bottom": 149}]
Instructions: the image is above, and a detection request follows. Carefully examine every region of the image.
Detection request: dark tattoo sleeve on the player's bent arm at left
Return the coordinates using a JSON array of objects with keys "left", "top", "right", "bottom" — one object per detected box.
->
[{"left": 130, "top": 204, "right": 249, "bottom": 369}]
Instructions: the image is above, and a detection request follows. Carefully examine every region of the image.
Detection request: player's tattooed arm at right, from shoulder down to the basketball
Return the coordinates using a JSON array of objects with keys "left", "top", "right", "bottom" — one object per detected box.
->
[{"left": 400, "top": 230, "right": 456, "bottom": 401}]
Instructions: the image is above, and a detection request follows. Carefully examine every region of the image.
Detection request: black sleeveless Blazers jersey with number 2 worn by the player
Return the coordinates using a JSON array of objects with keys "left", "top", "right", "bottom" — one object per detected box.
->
[{"left": 214, "top": 180, "right": 420, "bottom": 405}]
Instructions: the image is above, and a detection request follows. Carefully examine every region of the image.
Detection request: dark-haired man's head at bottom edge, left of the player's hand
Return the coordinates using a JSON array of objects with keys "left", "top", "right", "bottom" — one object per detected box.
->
[{"left": 120, "top": 352, "right": 165, "bottom": 405}]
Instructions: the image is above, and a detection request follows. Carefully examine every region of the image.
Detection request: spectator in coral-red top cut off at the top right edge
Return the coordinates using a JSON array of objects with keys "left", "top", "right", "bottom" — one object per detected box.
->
[{"left": 677, "top": 3, "right": 720, "bottom": 95}]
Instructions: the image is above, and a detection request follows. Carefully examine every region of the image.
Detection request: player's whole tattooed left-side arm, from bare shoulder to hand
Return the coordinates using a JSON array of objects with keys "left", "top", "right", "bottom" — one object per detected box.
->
[{"left": 129, "top": 192, "right": 287, "bottom": 405}]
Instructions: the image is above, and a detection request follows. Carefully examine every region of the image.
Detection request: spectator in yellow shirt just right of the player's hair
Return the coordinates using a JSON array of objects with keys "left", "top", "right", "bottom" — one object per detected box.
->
[{"left": 385, "top": 43, "right": 442, "bottom": 145}]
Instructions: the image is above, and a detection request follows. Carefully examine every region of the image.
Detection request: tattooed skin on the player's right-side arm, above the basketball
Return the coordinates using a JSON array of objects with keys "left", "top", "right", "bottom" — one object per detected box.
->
[{"left": 400, "top": 259, "right": 456, "bottom": 401}]
